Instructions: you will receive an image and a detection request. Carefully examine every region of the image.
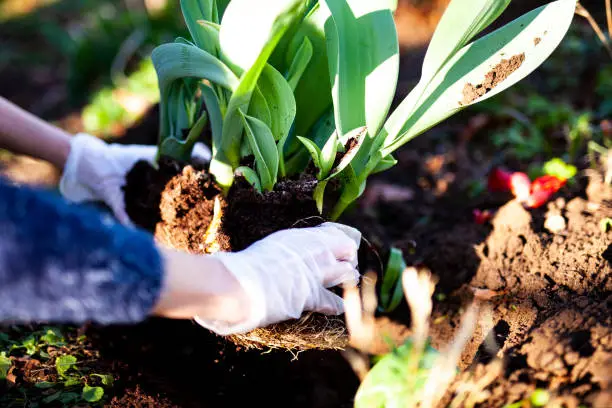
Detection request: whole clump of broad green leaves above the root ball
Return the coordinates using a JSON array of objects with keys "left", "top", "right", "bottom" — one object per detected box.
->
[{"left": 152, "top": 0, "right": 576, "bottom": 219}]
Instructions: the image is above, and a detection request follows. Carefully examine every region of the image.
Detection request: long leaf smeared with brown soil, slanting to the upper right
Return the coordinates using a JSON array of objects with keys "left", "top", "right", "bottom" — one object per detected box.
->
[{"left": 382, "top": 0, "right": 576, "bottom": 155}]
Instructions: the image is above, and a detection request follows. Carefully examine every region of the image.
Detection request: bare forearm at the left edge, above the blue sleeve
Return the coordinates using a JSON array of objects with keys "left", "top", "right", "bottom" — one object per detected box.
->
[{"left": 0, "top": 96, "right": 70, "bottom": 170}]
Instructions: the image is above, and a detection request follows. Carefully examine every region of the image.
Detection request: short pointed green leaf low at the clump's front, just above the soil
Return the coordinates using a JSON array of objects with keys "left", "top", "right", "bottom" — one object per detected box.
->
[{"left": 240, "top": 111, "right": 278, "bottom": 191}]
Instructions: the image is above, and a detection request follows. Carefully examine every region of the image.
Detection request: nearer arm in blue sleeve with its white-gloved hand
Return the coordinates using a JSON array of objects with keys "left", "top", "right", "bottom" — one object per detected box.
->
[{"left": 0, "top": 179, "right": 357, "bottom": 334}]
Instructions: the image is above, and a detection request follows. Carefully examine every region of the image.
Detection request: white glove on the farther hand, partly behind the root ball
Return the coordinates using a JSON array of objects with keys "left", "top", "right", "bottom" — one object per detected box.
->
[{"left": 59, "top": 133, "right": 211, "bottom": 225}]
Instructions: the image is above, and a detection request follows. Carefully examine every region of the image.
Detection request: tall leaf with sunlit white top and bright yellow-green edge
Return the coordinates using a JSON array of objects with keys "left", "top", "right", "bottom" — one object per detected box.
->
[{"left": 210, "top": 0, "right": 303, "bottom": 191}]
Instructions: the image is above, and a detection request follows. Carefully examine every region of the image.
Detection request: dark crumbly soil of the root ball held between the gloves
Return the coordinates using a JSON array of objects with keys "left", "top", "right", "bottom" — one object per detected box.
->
[{"left": 125, "top": 159, "right": 324, "bottom": 253}]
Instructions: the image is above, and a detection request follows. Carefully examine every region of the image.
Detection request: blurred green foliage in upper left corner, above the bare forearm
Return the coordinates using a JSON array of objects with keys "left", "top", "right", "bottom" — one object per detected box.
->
[{"left": 0, "top": 0, "right": 188, "bottom": 136}]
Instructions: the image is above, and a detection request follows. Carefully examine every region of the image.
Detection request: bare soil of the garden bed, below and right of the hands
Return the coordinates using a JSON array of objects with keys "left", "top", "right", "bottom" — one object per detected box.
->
[{"left": 49, "top": 106, "right": 612, "bottom": 407}]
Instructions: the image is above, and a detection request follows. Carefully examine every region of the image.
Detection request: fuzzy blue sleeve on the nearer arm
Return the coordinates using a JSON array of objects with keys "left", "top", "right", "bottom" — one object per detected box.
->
[{"left": 0, "top": 180, "right": 163, "bottom": 324}]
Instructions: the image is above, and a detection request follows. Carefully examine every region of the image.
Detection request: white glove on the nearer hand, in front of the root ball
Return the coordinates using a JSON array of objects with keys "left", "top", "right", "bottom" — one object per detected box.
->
[{"left": 195, "top": 223, "right": 361, "bottom": 336}]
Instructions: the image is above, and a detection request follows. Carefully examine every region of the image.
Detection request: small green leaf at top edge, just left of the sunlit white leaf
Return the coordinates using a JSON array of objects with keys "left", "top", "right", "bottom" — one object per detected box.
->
[{"left": 181, "top": 0, "right": 219, "bottom": 56}]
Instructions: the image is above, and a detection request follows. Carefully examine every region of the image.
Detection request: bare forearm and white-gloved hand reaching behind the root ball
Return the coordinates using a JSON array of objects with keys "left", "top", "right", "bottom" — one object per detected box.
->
[{"left": 0, "top": 97, "right": 210, "bottom": 224}]
